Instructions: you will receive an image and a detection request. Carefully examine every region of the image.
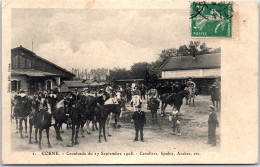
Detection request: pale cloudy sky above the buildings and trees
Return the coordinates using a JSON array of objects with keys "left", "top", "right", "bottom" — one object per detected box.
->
[{"left": 11, "top": 9, "right": 219, "bottom": 70}]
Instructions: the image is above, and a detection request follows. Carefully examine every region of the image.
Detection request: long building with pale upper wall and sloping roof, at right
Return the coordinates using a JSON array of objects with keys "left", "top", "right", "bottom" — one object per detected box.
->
[{"left": 160, "top": 53, "right": 221, "bottom": 94}]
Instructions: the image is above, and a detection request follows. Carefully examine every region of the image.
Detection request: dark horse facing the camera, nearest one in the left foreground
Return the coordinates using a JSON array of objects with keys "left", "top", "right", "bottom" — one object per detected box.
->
[{"left": 29, "top": 98, "right": 52, "bottom": 150}]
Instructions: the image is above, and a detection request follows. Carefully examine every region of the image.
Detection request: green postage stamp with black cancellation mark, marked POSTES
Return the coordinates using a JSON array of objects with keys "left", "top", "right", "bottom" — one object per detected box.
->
[{"left": 190, "top": 2, "right": 233, "bottom": 38}]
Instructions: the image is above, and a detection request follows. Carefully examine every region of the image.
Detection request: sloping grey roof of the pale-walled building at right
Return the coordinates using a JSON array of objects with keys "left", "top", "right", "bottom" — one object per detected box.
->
[{"left": 161, "top": 53, "right": 221, "bottom": 71}]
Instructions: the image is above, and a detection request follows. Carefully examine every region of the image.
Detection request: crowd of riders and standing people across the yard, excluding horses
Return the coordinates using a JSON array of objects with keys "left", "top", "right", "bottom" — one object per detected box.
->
[{"left": 12, "top": 78, "right": 220, "bottom": 145}]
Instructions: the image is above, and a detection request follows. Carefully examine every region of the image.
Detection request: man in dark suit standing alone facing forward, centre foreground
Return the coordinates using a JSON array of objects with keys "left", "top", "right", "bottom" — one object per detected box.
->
[{"left": 131, "top": 105, "right": 146, "bottom": 142}]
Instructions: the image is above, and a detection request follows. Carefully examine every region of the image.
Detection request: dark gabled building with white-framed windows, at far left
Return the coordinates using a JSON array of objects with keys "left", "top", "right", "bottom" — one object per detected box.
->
[{"left": 11, "top": 46, "right": 74, "bottom": 94}]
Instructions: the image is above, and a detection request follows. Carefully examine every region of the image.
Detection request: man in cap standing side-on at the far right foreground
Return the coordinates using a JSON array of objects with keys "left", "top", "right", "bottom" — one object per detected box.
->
[{"left": 208, "top": 105, "right": 219, "bottom": 146}]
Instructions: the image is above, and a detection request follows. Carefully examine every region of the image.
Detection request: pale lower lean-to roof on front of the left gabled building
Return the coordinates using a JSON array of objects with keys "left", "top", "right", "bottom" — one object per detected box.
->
[{"left": 11, "top": 69, "right": 57, "bottom": 77}]
